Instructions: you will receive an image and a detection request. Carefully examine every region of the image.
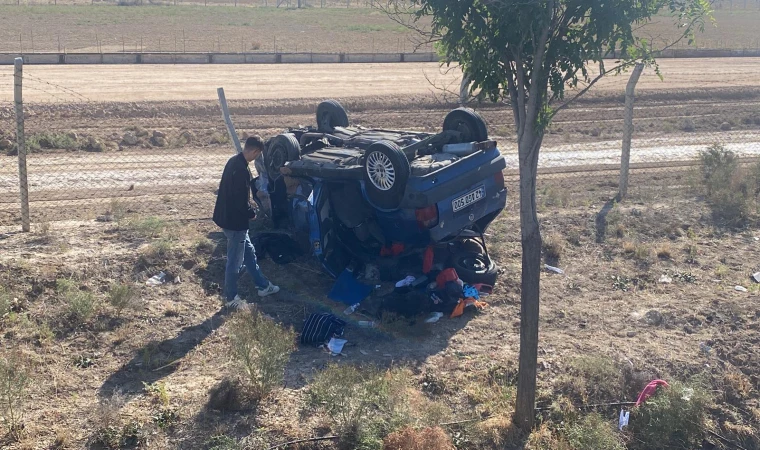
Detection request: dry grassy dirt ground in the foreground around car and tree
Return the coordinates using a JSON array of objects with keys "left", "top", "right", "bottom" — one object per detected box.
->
[{"left": 0, "top": 163, "right": 760, "bottom": 449}]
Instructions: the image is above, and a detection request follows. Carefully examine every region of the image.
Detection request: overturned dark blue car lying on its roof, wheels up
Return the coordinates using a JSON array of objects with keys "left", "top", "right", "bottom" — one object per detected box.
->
[{"left": 254, "top": 100, "right": 507, "bottom": 285}]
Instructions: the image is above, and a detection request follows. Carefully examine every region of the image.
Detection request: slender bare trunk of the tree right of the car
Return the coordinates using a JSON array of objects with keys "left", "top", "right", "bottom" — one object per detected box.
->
[{"left": 514, "top": 131, "right": 542, "bottom": 432}]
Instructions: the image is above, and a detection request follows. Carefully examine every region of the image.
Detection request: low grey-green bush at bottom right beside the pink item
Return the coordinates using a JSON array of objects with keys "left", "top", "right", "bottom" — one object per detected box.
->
[{"left": 628, "top": 383, "right": 710, "bottom": 450}]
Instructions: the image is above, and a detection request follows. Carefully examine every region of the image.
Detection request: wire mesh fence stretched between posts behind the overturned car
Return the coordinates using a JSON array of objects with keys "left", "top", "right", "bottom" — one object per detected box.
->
[{"left": 0, "top": 62, "right": 760, "bottom": 230}]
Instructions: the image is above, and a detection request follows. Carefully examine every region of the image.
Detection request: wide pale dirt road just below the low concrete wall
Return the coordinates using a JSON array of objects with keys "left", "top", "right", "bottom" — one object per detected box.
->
[{"left": 0, "top": 58, "right": 760, "bottom": 102}]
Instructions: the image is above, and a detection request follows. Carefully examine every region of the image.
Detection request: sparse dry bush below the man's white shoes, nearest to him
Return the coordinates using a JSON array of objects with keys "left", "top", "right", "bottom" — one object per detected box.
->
[{"left": 230, "top": 310, "right": 296, "bottom": 398}]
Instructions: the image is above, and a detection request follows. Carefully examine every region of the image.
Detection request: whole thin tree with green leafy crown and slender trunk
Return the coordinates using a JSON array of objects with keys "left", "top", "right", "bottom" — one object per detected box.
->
[{"left": 383, "top": 0, "right": 711, "bottom": 430}]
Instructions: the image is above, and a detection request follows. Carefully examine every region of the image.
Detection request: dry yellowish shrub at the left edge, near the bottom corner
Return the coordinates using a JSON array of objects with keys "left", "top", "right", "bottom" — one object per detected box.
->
[{"left": 0, "top": 354, "right": 30, "bottom": 439}]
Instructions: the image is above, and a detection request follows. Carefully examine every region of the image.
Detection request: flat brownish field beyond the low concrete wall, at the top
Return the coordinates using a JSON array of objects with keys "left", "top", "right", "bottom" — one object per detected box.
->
[{"left": 0, "top": 5, "right": 760, "bottom": 52}]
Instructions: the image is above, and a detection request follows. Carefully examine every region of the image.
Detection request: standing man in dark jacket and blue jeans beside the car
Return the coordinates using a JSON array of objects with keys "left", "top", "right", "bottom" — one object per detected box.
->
[{"left": 214, "top": 136, "right": 280, "bottom": 309}]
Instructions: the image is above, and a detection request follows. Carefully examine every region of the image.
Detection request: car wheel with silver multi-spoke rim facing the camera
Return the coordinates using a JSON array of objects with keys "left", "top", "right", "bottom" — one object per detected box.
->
[{"left": 364, "top": 141, "right": 411, "bottom": 209}]
